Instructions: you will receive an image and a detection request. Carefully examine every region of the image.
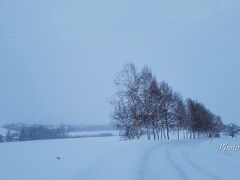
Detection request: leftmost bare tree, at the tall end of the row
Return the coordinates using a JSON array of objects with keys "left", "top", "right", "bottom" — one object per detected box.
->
[{"left": 111, "top": 63, "right": 141, "bottom": 139}]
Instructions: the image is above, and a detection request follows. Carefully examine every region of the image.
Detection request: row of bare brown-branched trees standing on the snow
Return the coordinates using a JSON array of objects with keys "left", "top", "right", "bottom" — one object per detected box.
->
[{"left": 110, "top": 63, "right": 222, "bottom": 140}]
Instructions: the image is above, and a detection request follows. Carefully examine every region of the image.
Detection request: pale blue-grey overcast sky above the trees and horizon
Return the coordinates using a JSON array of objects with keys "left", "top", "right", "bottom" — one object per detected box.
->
[{"left": 0, "top": 0, "right": 240, "bottom": 124}]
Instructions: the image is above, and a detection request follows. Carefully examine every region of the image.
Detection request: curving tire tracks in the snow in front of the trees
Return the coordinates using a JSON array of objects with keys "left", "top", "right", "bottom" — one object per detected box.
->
[{"left": 139, "top": 142, "right": 222, "bottom": 180}]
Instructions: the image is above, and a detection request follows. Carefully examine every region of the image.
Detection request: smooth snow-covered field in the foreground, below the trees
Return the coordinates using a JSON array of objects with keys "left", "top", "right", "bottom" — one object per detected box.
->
[{"left": 0, "top": 136, "right": 240, "bottom": 180}]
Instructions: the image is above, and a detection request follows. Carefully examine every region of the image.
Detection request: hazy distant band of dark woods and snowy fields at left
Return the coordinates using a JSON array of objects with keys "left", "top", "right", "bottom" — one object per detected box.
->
[{"left": 0, "top": 123, "right": 113, "bottom": 142}]
